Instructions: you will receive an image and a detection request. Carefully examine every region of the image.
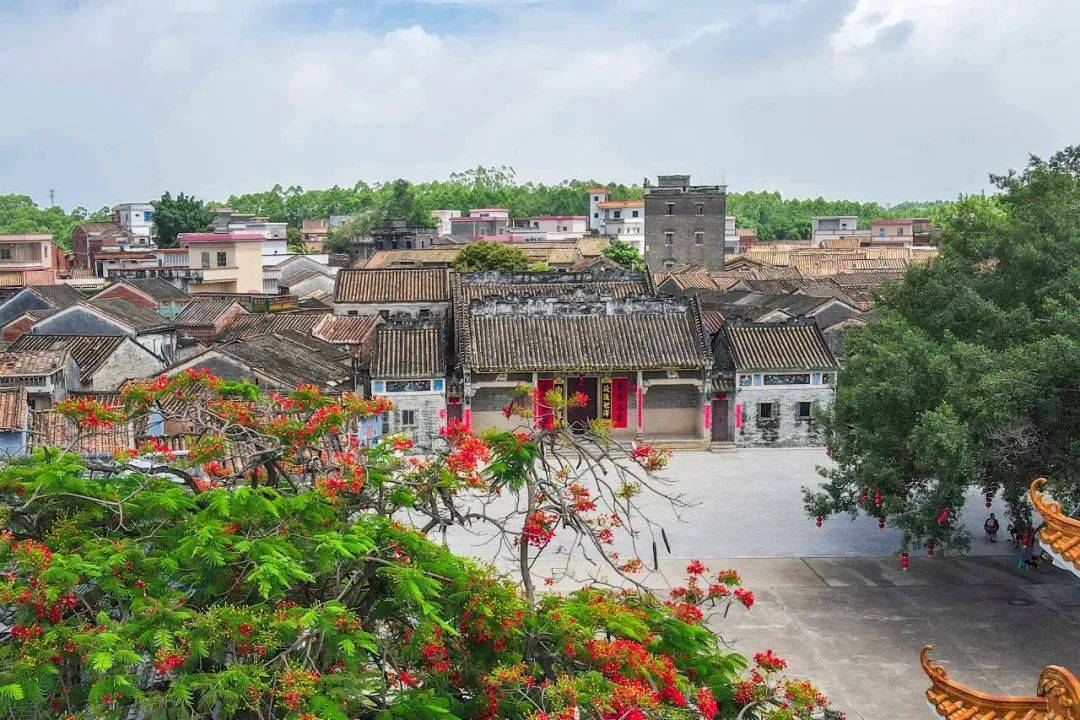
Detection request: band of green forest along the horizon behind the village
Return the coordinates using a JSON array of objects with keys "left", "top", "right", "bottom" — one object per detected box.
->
[{"left": 0, "top": 167, "right": 954, "bottom": 247}]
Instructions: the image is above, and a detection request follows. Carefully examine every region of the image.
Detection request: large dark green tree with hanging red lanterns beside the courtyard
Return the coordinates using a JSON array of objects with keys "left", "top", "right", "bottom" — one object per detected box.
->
[{"left": 806, "top": 147, "right": 1080, "bottom": 548}]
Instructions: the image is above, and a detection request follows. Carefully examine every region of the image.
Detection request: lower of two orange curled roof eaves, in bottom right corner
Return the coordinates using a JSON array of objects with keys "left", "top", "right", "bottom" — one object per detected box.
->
[{"left": 919, "top": 646, "right": 1080, "bottom": 720}]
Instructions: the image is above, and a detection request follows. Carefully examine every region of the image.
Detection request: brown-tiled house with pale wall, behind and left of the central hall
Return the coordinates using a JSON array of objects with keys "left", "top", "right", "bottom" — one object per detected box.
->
[{"left": 334, "top": 269, "right": 450, "bottom": 316}]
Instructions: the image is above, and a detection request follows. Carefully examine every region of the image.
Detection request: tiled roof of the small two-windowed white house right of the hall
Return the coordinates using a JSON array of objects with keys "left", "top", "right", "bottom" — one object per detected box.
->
[{"left": 725, "top": 323, "right": 836, "bottom": 370}]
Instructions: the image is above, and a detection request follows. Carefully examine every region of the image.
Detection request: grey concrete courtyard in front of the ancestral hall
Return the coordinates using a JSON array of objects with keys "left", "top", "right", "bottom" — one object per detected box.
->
[{"left": 440, "top": 449, "right": 1080, "bottom": 720}]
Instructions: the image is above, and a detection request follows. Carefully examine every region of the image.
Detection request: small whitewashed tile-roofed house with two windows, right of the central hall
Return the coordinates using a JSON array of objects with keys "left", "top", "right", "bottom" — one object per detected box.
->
[{"left": 713, "top": 317, "right": 837, "bottom": 447}]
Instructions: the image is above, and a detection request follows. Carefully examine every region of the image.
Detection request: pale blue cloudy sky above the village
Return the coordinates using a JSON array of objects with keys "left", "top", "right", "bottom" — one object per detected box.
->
[{"left": 0, "top": 0, "right": 1080, "bottom": 208}]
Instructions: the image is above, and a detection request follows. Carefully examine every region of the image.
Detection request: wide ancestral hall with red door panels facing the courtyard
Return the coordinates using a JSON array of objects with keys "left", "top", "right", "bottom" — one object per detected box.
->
[{"left": 460, "top": 290, "right": 711, "bottom": 447}]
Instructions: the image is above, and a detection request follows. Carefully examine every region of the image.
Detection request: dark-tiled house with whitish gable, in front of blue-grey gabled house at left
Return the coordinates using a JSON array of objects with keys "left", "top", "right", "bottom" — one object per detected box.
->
[{"left": 9, "top": 335, "right": 165, "bottom": 392}]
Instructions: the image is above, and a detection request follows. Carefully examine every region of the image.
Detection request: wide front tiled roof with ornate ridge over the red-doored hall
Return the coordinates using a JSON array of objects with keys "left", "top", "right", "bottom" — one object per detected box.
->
[{"left": 463, "top": 296, "right": 708, "bottom": 372}]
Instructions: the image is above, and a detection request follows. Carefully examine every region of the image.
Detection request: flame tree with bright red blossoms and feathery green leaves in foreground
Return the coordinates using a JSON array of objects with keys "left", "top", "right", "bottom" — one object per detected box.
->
[{"left": 0, "top": 371, "right": 825, "bottom": 720}]
